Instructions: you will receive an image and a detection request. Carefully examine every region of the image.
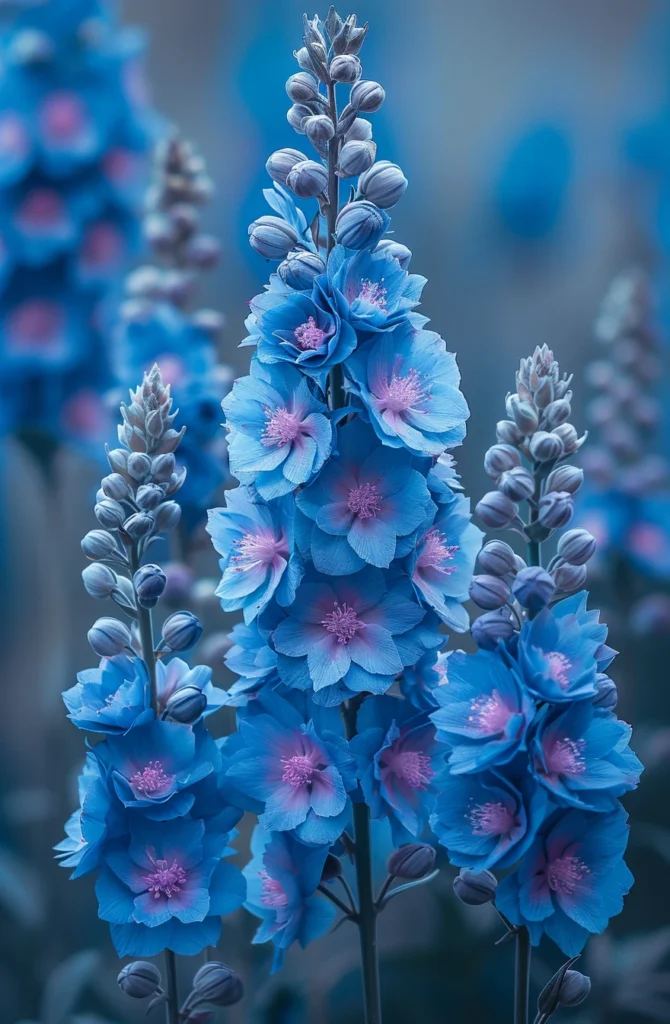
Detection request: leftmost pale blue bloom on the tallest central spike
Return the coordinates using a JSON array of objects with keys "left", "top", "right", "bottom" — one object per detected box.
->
[{"left": 207, "top": 487, "right": 302, "bottom": 623}]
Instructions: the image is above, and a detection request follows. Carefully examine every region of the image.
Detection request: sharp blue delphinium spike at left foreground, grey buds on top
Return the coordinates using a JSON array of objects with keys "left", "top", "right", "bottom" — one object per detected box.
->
[{"left": 56, "top": 367, "right": 246, "bottom": 1024}]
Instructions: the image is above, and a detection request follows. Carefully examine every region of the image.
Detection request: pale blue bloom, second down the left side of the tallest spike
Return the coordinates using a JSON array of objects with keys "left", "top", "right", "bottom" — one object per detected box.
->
[{"left": 223, "top": 358, "right": 332, "bottom": 500}]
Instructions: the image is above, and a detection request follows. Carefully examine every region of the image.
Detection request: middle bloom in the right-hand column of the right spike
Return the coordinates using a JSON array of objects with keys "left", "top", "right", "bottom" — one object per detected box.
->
[{"left": 530, "top": 700, "right": 642, "bottom": 811}]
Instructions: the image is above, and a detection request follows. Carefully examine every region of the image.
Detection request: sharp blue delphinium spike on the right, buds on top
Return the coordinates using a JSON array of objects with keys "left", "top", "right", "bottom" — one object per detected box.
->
[{"left": 430, "top": 346, "right": 641, "bottom": 1024}]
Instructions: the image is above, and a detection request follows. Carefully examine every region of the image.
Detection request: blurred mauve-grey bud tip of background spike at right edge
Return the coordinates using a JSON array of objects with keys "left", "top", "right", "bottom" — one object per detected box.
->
[{"left": 583, "top": 270, "right": 670, "bottom": 496}]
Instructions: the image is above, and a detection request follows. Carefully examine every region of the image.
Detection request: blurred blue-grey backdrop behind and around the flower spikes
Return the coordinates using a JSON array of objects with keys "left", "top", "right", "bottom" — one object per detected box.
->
[{"left": 0, "top": 0, "right": 670, "bottom": 1024}]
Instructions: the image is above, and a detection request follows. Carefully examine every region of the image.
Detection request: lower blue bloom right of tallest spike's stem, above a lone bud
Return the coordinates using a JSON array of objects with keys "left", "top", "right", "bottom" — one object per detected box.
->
[{"left": 349, "top": 696, "right": 445, "bottom": 845}]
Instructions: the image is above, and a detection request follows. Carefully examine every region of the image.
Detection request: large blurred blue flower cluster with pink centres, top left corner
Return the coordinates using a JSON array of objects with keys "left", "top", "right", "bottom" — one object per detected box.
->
[{"left": 0, "top": 0, "right": 153, "bottom": 452}]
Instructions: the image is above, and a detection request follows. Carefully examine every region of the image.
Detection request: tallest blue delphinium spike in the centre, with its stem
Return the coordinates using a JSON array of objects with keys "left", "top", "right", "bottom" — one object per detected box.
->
[{"left": 208, "top": 7, "right": 481, "bottom": 1024}]
